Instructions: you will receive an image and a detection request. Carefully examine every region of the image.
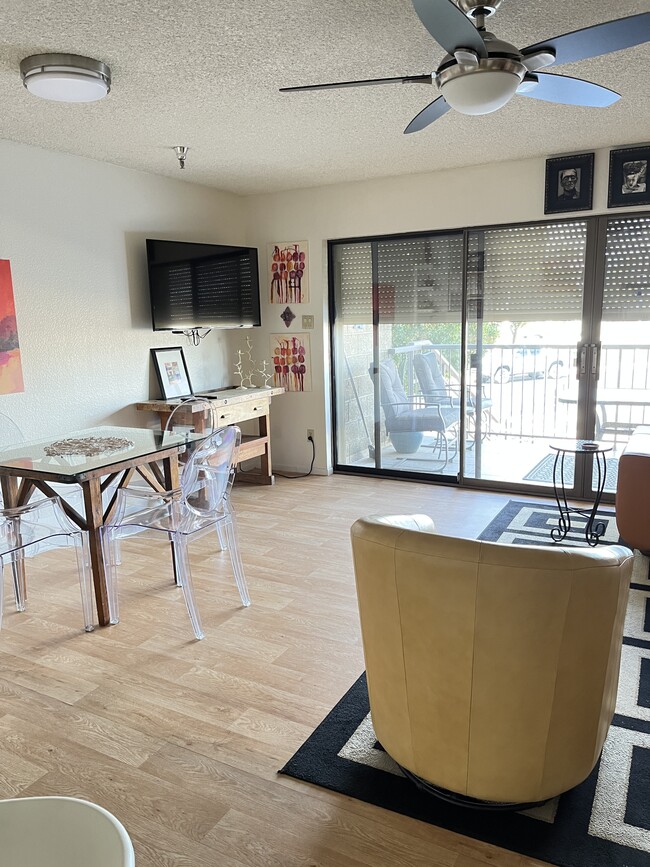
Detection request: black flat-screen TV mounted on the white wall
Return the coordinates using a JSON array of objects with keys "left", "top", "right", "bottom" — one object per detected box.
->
[{"left": 147, "top": 238, "right": 260, "bottom": 331}]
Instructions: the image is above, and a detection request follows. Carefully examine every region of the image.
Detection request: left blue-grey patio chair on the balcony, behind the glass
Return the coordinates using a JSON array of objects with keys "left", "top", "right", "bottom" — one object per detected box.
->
[{"left": 369, "top": 359, "right": 460, "bottom": 469}]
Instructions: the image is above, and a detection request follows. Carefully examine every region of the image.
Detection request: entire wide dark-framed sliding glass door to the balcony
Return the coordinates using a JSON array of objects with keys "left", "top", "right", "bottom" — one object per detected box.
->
[{"left": 330, "top": 215, "right": 650, "bottom": 499}]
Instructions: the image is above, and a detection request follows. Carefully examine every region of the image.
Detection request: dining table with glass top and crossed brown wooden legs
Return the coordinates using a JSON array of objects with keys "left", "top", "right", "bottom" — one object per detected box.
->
[{"left": 0, "top": 425, "right": 206, "bottom": 626}]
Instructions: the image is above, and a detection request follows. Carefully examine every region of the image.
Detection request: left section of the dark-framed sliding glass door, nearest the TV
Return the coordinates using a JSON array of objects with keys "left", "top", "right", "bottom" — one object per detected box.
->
[{"left": 330, "top": 232, "right": 472, "bottom": 479}]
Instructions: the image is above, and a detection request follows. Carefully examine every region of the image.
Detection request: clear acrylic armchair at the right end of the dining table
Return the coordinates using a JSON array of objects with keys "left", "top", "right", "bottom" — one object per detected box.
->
[{"left": 102, "top": 418, "right": 250, "bottom": 638}]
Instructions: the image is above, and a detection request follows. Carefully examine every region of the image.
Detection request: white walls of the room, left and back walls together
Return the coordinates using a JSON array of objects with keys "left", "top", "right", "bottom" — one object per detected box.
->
[{"left": 0, "top": 142, "right": 644, "bottom": 472}]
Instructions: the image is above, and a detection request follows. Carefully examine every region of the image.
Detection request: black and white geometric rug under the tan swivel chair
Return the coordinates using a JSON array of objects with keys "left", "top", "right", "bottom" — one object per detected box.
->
[{"left": 280, "top": 501, "right": 650, "bottom": 867}]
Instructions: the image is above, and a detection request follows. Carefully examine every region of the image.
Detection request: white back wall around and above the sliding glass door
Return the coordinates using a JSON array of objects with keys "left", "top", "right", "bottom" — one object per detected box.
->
[{"left": 242, "top": 151, "right": 647, "bottom": 472}]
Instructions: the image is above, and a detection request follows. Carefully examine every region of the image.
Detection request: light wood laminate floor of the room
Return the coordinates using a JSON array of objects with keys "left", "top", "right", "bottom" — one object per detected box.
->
[{"left": 0, "top": 475, "right": 543, "bottom": 867}]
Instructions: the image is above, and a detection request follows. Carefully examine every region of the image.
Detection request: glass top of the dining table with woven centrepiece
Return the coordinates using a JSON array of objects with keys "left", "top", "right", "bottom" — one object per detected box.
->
[{"left": 0, "top": 425, "right": 206, "bottom": 482}]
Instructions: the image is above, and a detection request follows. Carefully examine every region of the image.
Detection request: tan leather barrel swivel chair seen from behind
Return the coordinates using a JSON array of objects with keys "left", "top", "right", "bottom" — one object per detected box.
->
[{"left": 352, "top": 515, "right": 632, "bottom": 805}]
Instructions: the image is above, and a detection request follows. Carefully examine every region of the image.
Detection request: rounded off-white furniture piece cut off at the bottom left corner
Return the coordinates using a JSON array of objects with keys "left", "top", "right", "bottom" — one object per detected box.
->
[{"left": 0, "top": 796, "right": 135, "bottom": 867}]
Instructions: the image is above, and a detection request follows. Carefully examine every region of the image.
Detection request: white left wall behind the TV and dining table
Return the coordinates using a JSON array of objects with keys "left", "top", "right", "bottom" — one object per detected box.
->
[{"left": 0, "top": 142, "right": 245, "bottom": 436}]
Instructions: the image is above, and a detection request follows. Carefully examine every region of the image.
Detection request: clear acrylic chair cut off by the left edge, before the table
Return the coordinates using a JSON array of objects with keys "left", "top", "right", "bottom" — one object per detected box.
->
[{"left": 0, "top": 497, "right": 94, "bottom": 632}]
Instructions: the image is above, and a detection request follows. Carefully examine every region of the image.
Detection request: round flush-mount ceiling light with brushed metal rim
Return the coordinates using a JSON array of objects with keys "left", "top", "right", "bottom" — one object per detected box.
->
[{"left": 20, "top": 54, "right": 111, "bottom": 102}]
